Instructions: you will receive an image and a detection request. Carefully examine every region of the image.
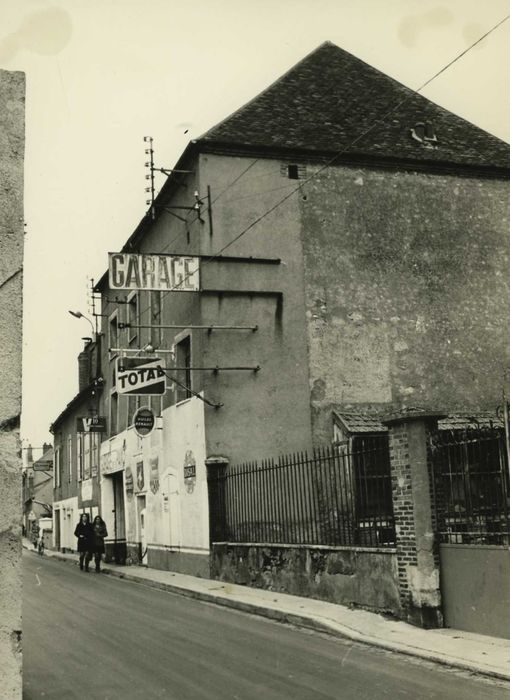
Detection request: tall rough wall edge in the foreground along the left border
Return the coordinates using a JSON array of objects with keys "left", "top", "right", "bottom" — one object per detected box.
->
[{"left": 0, "top": 71, "right": 25, "bottom": 700}]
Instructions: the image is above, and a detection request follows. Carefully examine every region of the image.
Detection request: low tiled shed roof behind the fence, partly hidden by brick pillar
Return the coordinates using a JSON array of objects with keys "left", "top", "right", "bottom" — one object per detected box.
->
[{"left": 333, "top": 411, "right": 503, "bottom": 434}]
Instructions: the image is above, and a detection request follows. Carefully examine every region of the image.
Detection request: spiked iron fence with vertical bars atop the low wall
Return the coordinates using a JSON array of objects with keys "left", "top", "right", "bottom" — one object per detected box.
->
[{"left": 209, "top": 435, "right": 395, "bottom": 546}]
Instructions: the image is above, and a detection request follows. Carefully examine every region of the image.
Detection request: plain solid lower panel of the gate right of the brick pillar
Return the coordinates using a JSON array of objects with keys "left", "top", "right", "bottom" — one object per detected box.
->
[{"left": 439, "top": 544, "right": 510, "bottom": 639}]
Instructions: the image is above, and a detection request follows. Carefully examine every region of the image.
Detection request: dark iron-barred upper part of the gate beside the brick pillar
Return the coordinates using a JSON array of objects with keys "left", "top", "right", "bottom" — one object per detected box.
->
[{"left": 432, "top": 428, "right": 510, "bottom": 545}]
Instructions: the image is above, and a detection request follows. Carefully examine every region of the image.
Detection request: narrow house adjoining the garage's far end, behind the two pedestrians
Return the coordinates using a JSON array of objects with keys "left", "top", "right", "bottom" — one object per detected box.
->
[{"left": 50, "top": 338, "right": 102, "bottom": 551}]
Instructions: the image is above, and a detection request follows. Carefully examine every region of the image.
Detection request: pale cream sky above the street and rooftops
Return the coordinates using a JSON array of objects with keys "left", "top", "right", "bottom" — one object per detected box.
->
[{"left": 0, "top": 0, "right": 510, "bottom": 446}]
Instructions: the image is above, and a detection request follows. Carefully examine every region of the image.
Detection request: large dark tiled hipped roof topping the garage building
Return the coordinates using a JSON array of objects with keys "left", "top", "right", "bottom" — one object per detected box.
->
[{"left": 198, "top": 42, "right": 510, "bottom": 170}]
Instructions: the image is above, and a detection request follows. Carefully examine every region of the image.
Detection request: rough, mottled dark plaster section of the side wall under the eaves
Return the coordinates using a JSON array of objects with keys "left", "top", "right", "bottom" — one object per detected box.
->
[{"left": 299, "top": 162, "right": 510, "bottom": 442}]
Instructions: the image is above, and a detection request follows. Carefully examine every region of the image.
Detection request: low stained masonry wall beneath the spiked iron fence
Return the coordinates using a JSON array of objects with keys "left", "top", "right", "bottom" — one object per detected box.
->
[{"left": 211, "top": 543, "right": 401, "bottom": 616}]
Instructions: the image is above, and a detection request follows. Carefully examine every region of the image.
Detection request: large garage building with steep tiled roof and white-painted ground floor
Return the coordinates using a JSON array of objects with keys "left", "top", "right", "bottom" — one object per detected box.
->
[{"left": 54, "top": 42, "right": 510, "bottom": 575}]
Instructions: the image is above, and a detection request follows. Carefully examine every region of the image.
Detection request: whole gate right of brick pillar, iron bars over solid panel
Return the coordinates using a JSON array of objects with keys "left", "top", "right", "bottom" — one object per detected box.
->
[{"left": 432, "top": 429, "right": 510, "bottom": 638}]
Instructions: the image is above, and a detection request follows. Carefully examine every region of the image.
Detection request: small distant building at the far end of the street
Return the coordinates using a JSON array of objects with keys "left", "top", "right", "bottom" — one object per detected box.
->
[{"left": 22, "top": 443, "right": 53, "bottom": 537}]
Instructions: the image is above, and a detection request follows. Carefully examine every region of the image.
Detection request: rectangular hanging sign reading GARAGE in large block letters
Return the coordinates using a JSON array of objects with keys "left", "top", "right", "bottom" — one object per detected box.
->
[{"left": 108, "top": 253, "right": 200, "bottom": 292}]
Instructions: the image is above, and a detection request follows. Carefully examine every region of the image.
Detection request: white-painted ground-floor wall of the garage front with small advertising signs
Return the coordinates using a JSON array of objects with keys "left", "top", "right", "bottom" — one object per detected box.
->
[{"left": 101, "top": 397, "right": 209, "bottom": 573}]
